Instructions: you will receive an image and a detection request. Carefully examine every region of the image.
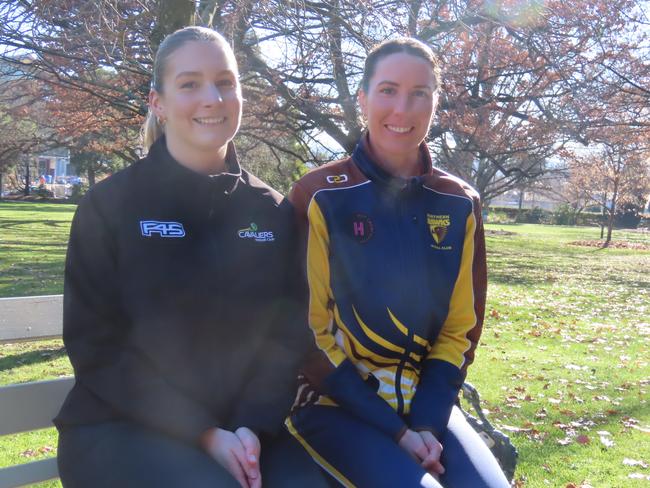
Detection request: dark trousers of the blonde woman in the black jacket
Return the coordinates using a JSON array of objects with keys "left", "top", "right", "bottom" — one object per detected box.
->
[{"left": 58, "top": 422, "right": 327, "bottom": 488}]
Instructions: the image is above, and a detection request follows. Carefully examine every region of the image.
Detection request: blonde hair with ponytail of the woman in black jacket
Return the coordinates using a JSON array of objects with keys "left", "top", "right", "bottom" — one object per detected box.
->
[{"left": 142, "top": 26, "right": 237, "bottom": 150}]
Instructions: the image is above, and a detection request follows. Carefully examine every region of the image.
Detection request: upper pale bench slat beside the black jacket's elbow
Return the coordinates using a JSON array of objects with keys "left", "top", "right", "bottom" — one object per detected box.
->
[{"left": 0, "top": 295, "right": 63, "bottom": 343}]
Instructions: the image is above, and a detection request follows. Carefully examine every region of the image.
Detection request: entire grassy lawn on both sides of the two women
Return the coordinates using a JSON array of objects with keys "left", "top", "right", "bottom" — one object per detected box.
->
[{"left": 0, "top": 203, "right": 650, "bottom": 488}]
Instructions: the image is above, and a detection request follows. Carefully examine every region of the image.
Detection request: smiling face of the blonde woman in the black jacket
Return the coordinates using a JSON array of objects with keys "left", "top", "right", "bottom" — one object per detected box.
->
[{"left": 149, "top": 41, "right": 242, "bottom": 162}]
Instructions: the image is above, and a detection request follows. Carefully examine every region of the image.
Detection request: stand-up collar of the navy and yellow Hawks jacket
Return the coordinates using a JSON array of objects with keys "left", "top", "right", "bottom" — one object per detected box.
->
[{"left": 352, "top": 132, "right": 433, "bottom": 193}]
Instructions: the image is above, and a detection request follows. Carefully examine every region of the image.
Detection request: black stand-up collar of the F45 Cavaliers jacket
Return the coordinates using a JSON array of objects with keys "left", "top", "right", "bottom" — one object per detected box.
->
[{"left": 149, "top": 135, "right": 242, "bottom": 195}]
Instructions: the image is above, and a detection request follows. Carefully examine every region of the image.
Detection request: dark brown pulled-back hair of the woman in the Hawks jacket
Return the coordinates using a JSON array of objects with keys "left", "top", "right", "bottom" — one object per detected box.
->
[{"left": 359, "top": 37, "right": 440, "bottom": 93}]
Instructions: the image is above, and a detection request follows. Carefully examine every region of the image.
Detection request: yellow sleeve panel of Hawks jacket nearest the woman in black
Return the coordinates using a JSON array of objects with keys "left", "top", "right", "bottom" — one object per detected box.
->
[{"left": 307, "top": 199, "right": 346, "bottom": 367}]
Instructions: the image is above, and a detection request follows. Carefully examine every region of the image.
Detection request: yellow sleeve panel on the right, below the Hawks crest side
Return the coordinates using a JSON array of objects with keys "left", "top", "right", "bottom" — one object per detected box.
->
[{"left": 427, "top": 212, "right": 477, "bottom": 368}]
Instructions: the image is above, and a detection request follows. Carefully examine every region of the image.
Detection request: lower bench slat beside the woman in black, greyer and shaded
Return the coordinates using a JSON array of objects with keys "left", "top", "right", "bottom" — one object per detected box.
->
[{"left": 0, "top": 376, "right": 74, "bottom": 436}]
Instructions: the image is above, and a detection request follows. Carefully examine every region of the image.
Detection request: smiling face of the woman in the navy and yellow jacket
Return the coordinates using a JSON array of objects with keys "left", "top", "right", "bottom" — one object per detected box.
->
[{"left": 359, "top": 53, "right": 438, "bottom": 160}]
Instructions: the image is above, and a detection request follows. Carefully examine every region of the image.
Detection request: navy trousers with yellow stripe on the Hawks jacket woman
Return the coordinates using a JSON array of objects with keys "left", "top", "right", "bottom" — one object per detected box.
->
[{"left": 288, "top": 406, "right": 510, "bottom": 488}]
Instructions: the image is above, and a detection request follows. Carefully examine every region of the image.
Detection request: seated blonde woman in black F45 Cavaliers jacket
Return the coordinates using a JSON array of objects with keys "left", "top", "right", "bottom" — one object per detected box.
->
[{"left": 55, "top": 27, "right": 322, "bottom": 488}]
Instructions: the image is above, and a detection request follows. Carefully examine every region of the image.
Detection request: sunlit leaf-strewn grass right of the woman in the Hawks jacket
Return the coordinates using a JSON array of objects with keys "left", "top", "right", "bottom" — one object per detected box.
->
[{"left": 468, "top": 225, "right": 650, "bottom": 488}]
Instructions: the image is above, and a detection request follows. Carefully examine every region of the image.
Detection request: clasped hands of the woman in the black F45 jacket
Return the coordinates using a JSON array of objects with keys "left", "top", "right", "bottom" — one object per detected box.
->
[{"left": 201, "top": 427, "right": 262, "bottom": 488}]
